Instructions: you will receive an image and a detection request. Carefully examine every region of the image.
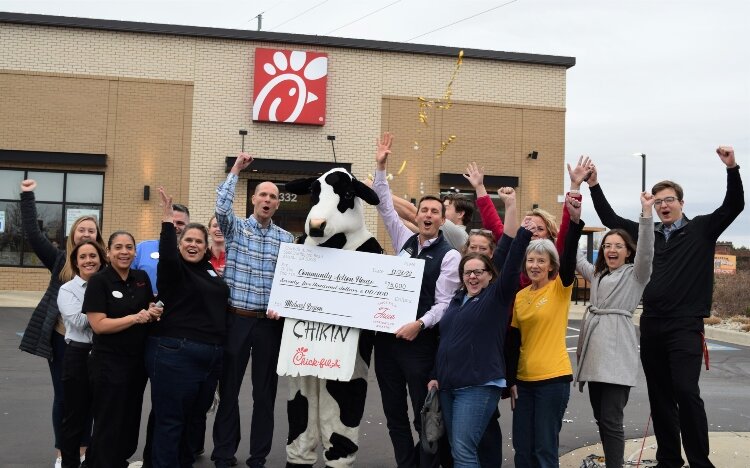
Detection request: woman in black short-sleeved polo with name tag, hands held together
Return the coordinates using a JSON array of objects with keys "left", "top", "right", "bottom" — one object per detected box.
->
[{"left": 82, "top": 231, "right": 161, "bottom": 468}]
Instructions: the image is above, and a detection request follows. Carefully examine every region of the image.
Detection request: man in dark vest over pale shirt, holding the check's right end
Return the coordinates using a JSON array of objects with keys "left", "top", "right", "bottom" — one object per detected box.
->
[{"left": 372, "top": 133, "right": 461, "bottom": 468}]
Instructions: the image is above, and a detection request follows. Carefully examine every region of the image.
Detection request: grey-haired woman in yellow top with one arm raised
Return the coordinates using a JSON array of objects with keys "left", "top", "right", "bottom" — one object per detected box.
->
[{"left": 506, "top": 196, "right": 583, "bottom": 468}]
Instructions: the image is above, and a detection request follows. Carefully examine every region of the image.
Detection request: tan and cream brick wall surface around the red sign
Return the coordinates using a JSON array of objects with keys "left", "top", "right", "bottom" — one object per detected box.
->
[{"left": 0, "top": 24, "right": 566, "bottom": 290}]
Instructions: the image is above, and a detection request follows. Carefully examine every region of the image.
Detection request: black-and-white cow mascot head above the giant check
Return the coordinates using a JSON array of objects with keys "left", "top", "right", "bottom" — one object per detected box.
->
[{"left": 286, "top": 168, "right": 383, "bottom": 253}]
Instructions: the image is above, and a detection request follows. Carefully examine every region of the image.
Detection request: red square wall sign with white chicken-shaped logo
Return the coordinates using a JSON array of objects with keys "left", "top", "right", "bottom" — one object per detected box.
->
[{"left": 253, "top": 48, "right": 328, "bottom": 125}]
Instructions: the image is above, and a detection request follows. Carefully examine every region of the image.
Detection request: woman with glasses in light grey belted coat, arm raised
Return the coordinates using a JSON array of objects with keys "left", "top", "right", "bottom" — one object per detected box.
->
[{"left": 575, "top": 192, "right": 666, "bottom": 468}]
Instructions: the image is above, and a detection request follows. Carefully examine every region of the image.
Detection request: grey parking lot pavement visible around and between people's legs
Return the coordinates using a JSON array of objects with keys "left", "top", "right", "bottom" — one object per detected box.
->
[{"left": 0, "top": 307, "right": 750, "bottom": 468}]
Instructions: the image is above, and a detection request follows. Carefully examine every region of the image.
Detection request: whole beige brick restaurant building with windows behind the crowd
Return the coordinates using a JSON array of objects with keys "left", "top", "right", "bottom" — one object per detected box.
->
[{"left": 0, "top": 13, "right": 575, "bottom": 290}]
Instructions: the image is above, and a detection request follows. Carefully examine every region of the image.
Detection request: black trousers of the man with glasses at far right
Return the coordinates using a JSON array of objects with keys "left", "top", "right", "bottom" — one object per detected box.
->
[{"left": 640, "top": 317, "right": 713, "bottom": 468}]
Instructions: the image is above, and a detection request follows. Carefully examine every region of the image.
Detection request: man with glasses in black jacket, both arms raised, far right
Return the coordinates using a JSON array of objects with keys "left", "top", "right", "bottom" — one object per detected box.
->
[{"left": 588, "top": 146, "right": 745, "bottom": 468}]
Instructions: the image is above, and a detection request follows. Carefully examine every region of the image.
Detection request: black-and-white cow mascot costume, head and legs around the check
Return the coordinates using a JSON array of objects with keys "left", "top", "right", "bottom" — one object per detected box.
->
[{"left": 282, "top": 168, "right": 383, "bottom": 468}]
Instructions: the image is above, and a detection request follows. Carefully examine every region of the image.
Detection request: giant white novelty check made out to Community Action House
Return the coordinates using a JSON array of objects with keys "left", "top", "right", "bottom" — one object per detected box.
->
[{"left": 268, "top": 244, "right": 424, "bottom": 333}]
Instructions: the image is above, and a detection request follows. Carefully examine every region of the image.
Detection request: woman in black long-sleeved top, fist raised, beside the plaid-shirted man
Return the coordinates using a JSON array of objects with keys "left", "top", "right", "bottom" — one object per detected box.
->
[{"left": 146, "top": 187, "right": 229, "bottom": 468}]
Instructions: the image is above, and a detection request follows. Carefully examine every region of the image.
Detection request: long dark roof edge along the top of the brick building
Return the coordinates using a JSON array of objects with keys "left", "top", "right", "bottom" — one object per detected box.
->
[{"left": 0, "top": 12, "right": 576, "bottom": 68}]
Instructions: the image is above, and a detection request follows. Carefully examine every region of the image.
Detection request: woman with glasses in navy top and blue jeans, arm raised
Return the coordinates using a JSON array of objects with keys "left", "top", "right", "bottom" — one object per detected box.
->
[{"left": 428, "top": 219, "right": 535, "bottom": 467}]
